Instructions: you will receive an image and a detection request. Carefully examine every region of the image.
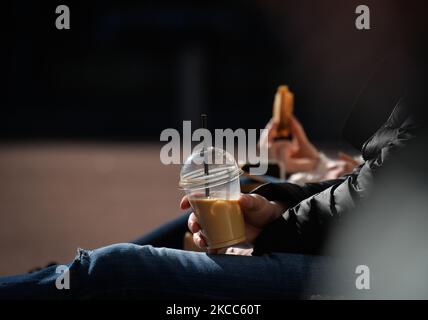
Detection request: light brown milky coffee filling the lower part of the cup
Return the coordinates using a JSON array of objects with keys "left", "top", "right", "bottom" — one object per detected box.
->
[{"left": 190, "top": 199, "right": 245, "bottom": 249}]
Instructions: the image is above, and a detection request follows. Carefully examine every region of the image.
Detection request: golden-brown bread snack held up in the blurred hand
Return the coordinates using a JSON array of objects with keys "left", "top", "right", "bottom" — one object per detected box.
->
[{"left": 272, "top": 85, "right": 294, "bottom": 138}]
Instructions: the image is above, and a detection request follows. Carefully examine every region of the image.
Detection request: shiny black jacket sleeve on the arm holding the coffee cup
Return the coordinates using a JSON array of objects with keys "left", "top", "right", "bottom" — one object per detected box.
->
[{"left": 253, "top": 114, "right": 418, "bottom": 255}]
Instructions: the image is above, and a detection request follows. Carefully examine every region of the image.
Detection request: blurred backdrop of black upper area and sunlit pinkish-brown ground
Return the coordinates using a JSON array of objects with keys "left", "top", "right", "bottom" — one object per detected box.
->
[{"left": 0, "top": 0, "right": 422, "bottom": 275}]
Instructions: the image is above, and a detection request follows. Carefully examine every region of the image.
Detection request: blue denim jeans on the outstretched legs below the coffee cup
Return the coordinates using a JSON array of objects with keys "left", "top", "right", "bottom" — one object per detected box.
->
[{"left": 0, "top": 215, "right": 352, "bottom": 299}]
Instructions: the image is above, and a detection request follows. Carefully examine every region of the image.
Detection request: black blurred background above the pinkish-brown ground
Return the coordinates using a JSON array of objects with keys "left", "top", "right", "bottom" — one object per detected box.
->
[{"left": 0, "top": 0, "right": 424, "bottom": 142}]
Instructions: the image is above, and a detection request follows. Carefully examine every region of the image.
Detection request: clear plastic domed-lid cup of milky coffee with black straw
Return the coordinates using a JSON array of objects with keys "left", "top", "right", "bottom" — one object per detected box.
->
[{"left": 180, "top": 147, "right": 245, "bottom": 249}]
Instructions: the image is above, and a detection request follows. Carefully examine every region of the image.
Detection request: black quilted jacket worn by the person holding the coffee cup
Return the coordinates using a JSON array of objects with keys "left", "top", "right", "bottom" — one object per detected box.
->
[{"left": 253, "top": 94, "right": 421, "bottom": 255}]
